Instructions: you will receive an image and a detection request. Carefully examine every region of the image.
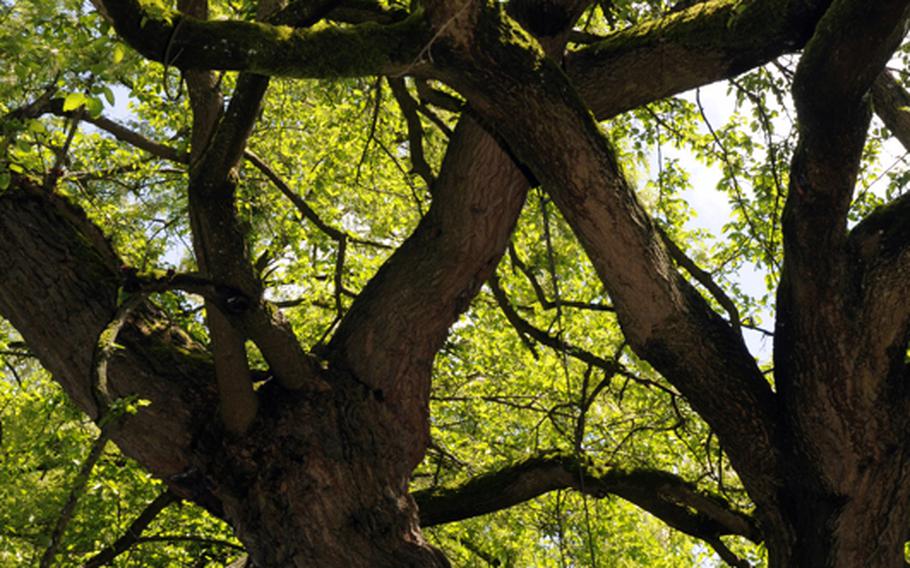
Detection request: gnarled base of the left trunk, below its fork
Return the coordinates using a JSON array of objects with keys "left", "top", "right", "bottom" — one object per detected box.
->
[{"left": 198, "top": 376, "right": 449, "bottom": 568}]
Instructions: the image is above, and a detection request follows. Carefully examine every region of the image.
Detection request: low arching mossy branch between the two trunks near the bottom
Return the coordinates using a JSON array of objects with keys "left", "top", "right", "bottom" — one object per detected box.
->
[{"left": 413, "top": 455, "right": 762, "bottom": 542}]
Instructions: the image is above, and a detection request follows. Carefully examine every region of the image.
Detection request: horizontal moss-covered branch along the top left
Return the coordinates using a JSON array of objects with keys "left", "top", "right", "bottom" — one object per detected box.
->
[{"left": 98, "top": 0, "right": 431, "bottom": 77}]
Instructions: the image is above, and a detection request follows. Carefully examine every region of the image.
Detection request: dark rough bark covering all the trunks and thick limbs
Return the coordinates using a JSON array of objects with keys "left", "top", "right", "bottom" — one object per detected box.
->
[{"left": 0, "top": 0, "right": 910, "bottom": 567}]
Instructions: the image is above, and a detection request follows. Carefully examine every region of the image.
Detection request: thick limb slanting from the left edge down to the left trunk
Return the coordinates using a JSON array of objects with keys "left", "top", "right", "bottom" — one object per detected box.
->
[{"left": 0, "top": 176, "right": 220, "bottom": 512}]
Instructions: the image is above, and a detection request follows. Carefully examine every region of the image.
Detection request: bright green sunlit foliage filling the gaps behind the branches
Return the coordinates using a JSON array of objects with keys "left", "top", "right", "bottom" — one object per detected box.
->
[{"left": 0, "top": 0, "right": 910, "bottom": 567}]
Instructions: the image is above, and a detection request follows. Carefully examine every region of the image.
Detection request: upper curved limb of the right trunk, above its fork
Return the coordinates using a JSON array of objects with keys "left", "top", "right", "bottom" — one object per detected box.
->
[{"left": 783, "top": 0, "right": 910, "bottom": 262}]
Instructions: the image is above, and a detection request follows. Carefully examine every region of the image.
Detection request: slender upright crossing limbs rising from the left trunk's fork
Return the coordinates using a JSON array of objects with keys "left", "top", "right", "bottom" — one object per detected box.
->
[{"left": 178, "top": 0, "right": 330, "bottom": 432}]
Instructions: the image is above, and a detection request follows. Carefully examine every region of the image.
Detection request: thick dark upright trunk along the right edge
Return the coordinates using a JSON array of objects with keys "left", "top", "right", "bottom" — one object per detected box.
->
[{"left": 768, "top": 1, "right": 910, "bottom": 566}]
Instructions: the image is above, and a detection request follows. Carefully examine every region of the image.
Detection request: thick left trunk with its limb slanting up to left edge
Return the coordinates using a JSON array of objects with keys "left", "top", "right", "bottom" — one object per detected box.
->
[{"left": 0, "top": 180, "right": 448, "bottom": 567}]
